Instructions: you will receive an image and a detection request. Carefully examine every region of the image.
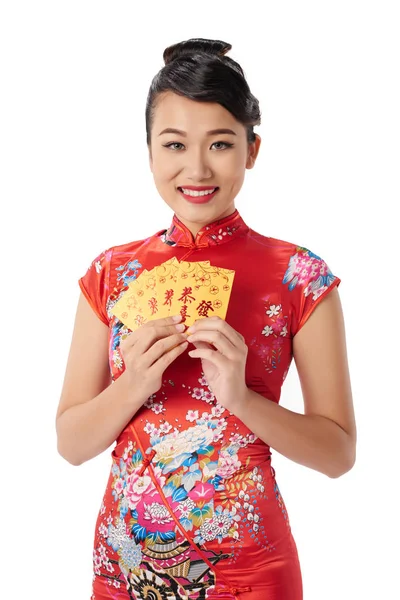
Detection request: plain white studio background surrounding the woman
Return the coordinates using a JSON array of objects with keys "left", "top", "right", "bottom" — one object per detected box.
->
[{"left": 0, "top": 0, "right": 400, "bottom": 600}]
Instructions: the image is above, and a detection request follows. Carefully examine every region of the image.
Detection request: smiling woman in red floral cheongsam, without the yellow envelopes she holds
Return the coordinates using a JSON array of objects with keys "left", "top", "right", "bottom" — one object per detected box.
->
[{"left": 57, "top": 39, "right": 356, "bottom": 600}]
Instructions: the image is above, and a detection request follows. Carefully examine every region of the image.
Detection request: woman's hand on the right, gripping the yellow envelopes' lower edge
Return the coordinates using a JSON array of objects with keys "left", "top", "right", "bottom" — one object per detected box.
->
[{"left": 186, "top": 317, "right": 248, "bottom": 413}]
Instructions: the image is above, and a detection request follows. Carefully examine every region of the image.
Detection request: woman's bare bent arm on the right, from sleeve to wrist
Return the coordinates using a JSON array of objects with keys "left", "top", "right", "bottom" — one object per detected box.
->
[{"left": 232, "top": 288, "right": 357, "bottom": 478}]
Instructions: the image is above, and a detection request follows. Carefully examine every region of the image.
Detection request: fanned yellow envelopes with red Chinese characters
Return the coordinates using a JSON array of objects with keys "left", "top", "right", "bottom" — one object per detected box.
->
[{"left": 111, "top": 258, "right": 235, "bottom": 331}]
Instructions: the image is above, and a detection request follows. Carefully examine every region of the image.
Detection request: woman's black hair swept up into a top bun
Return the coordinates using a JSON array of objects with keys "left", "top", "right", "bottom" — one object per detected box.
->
[{"left": 146, "top": 38, "right": 261, "bottom": 145}]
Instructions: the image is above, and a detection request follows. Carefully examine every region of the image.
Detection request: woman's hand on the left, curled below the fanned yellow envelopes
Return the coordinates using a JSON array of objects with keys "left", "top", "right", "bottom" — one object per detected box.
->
[{"left": 120, "top": 317, "right": 188, "bottom": 402}]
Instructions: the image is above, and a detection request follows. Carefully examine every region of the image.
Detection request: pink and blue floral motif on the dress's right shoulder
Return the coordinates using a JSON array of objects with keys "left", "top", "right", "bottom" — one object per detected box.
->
[{"left": 282, "top": 246, "right": 335, "bottom": 300}]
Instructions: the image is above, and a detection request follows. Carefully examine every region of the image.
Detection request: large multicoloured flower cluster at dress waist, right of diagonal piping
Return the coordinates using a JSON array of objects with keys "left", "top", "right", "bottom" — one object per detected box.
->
[{"left": 133, "top": 374, "right": 275, "bottom": 560}]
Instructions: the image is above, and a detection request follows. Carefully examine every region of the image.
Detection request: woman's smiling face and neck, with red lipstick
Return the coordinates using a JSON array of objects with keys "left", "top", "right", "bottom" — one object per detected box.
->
[{"left": 149, "top": 92, "right": 261, "bottom": 237}]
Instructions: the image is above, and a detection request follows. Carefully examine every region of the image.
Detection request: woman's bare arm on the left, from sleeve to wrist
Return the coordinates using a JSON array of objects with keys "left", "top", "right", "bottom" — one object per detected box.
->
[{"left": 56, "top": 293, "right": 146, "bottom": 465}]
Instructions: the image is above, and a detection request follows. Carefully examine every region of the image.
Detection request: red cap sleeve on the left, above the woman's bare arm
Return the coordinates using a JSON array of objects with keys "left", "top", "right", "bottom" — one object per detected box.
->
[{"left": 78, "top": 249, "right": 112, "bottom": 326}]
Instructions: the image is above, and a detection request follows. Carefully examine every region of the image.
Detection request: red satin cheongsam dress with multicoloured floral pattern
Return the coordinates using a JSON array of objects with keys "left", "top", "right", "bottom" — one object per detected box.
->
[{"left": 79, "top": 210, "right": 340, "bottom": 600}]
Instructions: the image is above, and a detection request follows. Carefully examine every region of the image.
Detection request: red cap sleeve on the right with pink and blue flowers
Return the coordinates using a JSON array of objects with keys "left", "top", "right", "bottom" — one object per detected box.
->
[{"left": 283, "top": 246, "right": 341, "bottom": 337}]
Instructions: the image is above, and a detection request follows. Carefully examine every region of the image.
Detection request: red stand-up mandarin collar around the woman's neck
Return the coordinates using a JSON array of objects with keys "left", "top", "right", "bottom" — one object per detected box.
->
[{"left": 160, "top": 209, "right": 249, "bottom": 247}]
